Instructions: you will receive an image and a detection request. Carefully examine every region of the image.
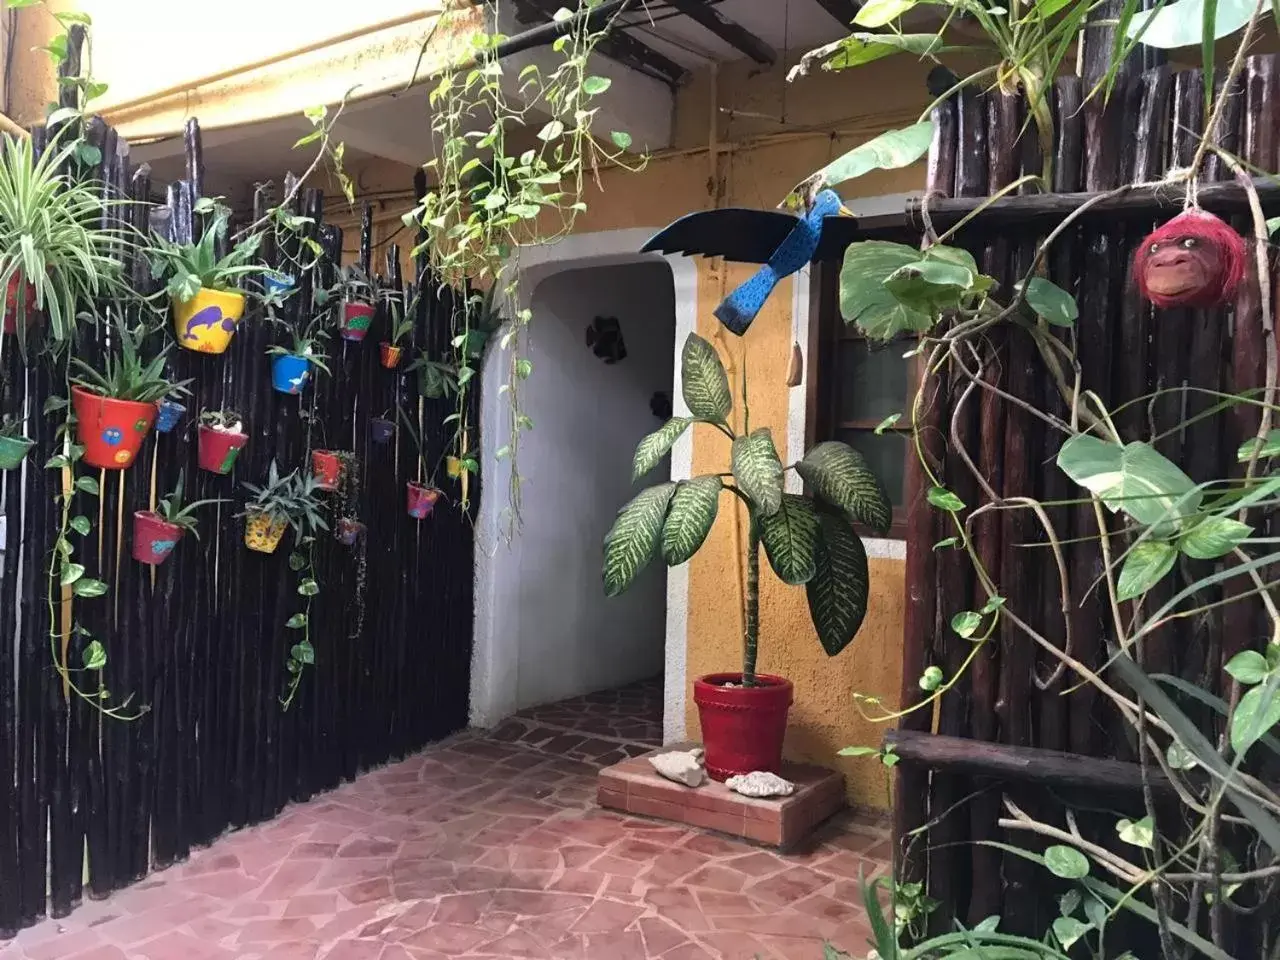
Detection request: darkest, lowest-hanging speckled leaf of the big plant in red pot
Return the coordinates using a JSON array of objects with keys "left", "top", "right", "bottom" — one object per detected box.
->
[{"left": 805, "top": 511, "right": 868, "bottom": 657}]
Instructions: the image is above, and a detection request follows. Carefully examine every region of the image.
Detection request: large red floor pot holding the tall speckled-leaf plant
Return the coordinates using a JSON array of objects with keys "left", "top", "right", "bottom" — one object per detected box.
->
[{"left": 694, "top": 673, "right": 792, "bottom": 781}]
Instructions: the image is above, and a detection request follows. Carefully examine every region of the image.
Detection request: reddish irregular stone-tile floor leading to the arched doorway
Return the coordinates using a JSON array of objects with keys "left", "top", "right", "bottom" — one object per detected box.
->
[{"left": 0, "top": 686, "right": 888, "bottom": 960}]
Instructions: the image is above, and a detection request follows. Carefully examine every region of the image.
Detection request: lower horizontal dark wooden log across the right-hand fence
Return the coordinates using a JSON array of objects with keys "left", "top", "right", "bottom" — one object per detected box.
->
[{"left": 884, "top": 730, "right": 1172, "bottom": 794}]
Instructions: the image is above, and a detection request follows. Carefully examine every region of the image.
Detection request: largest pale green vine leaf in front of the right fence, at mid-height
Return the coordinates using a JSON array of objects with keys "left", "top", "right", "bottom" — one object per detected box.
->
[{"left": 1057, "top": 434, "right": 1203, "bottom": 536}]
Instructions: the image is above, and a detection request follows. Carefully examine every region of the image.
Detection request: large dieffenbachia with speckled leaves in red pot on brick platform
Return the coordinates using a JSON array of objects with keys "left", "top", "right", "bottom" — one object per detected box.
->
[{"left": 604, "top": 334, "right": 892, "bottom": 780}]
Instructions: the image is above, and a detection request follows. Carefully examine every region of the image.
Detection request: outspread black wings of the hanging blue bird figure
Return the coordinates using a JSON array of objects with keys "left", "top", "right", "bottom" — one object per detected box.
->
[{"left": 640, "top": 207, "right": 858, "bottom": 264}]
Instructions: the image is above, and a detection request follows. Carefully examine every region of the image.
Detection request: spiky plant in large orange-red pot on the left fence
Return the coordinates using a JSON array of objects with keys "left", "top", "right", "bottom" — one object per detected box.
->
[{"left": 72, "top": 320, "right": 191, "bottom": 470}]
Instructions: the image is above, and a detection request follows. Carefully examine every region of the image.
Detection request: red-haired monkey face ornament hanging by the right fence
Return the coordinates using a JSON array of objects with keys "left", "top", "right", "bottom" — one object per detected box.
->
[{"left": 1133, "top": 207, "right": 1244, "bottom": 307}]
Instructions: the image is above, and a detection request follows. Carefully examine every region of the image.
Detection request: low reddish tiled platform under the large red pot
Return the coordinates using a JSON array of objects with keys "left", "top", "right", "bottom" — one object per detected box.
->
[{"left": 596, "top": 744, "right": 845, "bottom": 850}]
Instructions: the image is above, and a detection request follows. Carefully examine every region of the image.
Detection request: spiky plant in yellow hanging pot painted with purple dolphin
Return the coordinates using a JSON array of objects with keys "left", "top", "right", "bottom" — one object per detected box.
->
[{"left": 150, "top": 207, "right": 269, "bottom": 353}]
